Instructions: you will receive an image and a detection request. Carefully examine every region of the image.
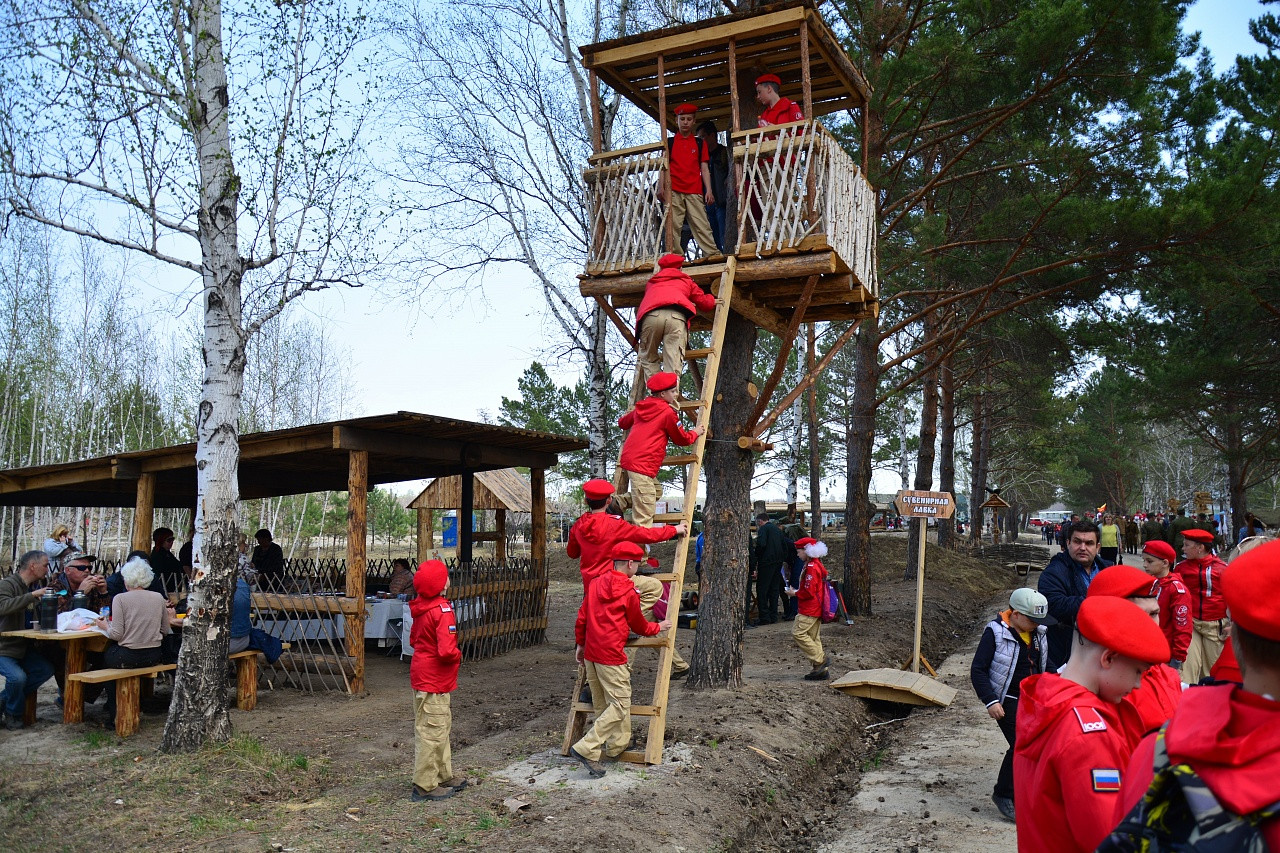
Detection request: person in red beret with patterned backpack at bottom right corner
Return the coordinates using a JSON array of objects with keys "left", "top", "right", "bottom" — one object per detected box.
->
[{"left": 1108, "top": 533, "right": 1280, "bottom": 850}]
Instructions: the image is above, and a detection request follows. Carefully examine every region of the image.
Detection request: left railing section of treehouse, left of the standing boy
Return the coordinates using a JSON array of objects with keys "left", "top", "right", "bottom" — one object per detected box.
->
[{"left": 582, "top": 142, "right": 667, "bottom": 274}]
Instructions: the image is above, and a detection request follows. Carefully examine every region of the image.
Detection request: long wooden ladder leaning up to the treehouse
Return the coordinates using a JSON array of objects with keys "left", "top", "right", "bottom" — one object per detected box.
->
[{"left": 561, "top": 255, "right": 737, "bottom": 765}]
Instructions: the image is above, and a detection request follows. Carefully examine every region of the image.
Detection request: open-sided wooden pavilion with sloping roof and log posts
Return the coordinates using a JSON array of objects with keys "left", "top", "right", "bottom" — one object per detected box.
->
[{"left": 0, "top": 411, "right": 586, "bottom": 693}]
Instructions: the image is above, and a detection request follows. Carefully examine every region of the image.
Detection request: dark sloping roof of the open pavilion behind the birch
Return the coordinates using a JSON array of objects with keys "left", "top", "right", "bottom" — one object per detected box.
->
[{"left": 0, "top": 411, "right": 586, "bottom": 508}]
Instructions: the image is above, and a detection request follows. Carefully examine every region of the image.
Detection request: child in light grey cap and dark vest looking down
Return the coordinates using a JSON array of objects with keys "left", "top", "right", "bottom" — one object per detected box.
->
[{"left": 969, "top": 587, "right": 1056, "bottom": 821}]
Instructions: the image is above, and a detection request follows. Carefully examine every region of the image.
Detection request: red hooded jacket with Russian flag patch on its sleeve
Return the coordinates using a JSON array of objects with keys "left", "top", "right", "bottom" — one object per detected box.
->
[{"left": 1014, "top": 672, "right": 1133, "bottom": 853}]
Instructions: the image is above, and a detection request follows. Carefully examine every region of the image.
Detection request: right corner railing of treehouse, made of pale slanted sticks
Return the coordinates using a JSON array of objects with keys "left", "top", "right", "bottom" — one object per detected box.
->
[{"left": 732, "top": 122, "right": 878, "bottom": 293}]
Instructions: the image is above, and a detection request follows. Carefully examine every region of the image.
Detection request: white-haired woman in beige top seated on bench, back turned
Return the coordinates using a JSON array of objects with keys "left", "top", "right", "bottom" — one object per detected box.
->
[{"left": 97, "top": 557, "right": 178, "bottom": 722}]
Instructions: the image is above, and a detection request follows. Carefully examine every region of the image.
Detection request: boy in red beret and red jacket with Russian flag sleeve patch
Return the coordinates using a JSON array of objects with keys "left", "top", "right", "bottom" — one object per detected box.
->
[{"left": 1014, "top": 596, "right": 1169, "bottom": 853}]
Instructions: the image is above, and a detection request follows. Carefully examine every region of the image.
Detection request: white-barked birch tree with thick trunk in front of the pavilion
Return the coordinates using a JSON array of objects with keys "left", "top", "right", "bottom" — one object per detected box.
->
[{"left": 0, "top": 0, "right": 378, "bottom": 752}]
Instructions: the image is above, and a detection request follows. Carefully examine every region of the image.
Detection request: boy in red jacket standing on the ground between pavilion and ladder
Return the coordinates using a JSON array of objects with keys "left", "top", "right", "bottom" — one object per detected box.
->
[{"left": 408, "top": 560, "right": 467, "bottom": 802}]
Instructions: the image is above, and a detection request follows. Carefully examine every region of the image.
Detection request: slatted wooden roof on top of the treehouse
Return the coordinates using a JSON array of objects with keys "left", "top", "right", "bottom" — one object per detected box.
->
[{"left": 580, "top": 0, "right": 872, "bottom": 127}]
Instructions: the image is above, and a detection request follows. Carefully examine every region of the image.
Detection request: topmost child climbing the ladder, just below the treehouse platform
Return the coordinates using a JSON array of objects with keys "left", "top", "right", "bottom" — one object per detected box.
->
[{"left": 631, "top": 254, "right": 716, "bottom": 403}]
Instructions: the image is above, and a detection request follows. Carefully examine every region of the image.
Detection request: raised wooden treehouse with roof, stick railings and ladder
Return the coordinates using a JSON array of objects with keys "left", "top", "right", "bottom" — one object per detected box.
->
[{"left": 563, "top": 0, "right": 878, "bottom": 763}]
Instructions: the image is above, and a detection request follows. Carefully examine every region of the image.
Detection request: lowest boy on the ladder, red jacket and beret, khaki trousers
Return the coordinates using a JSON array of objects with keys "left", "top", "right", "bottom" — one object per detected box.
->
[{"left": 570, "top": 542, "right": 671, "bottom": 779}]
